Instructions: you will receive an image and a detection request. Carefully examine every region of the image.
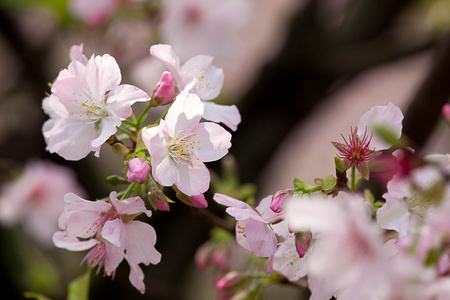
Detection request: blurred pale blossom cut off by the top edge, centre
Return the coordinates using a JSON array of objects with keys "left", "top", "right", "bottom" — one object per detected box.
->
[{"left": 161, "top": 0, "right": 252, "bottom": 60}]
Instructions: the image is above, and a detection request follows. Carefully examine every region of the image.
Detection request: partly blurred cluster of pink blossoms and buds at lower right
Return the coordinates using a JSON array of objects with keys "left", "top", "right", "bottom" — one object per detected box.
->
[{"left": 208, "top": 103, "right": 450, "bottom": 299}]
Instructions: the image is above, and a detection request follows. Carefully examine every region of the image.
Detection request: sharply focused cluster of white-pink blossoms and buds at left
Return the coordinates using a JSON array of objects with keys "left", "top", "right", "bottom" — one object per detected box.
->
[{"left": 37, "top": 44, "right": 240, "bottom": 293}]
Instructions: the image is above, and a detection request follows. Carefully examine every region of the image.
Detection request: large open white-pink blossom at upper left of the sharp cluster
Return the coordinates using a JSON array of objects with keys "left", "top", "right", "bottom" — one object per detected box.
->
[{"left": 42, "top": 46, "right": 149, "bottom": 160}]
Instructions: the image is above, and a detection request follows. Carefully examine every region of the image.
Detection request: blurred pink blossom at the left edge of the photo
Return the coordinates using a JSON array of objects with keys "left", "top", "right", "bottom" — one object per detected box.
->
[{"left": 0, "top": 161, "right": 84, "bottom": 246}]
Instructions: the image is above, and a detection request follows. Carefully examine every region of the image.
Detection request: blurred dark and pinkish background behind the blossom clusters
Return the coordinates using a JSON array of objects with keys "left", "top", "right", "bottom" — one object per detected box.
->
[{"left": 0, "top": 0, "right": 450, "bottom": 299}]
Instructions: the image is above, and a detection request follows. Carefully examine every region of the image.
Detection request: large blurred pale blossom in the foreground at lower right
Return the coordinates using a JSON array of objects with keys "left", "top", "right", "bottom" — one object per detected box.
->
[{"left": 285, "top": 192, "right": 389, "bottom": 299}]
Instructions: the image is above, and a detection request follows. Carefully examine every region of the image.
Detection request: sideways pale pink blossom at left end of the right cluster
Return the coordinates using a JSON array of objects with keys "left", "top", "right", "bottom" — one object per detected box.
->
[{"left": 213, "top": 193, "right": 282, "bottom": 257}]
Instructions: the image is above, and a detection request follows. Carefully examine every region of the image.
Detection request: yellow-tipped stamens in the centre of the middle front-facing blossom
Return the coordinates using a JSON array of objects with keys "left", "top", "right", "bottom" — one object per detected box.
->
[{"left": 167, "top": 130, "right": 201, "bottom": 166}]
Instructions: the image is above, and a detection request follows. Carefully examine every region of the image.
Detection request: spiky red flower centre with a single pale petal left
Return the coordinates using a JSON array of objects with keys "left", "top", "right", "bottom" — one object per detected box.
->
[{"left": 331, "top": 103, "right": 403, "bottom": 179}]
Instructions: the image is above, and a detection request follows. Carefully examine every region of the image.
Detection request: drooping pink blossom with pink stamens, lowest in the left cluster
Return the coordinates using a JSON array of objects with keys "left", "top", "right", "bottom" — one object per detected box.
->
[{"left": 53, "top": 192, "right": 161, "bottom": 293}]
